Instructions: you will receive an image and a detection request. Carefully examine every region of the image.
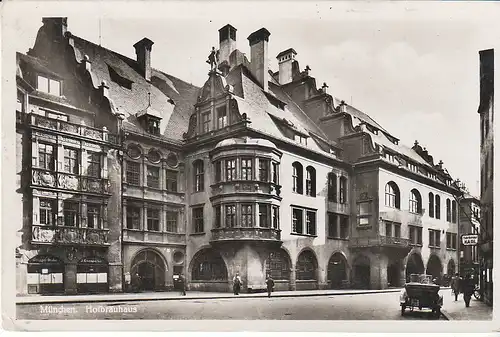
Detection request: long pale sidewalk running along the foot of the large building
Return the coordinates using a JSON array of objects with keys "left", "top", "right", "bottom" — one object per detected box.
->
[{"left": 16, "top": 288, "right": 410, "bottom": 304}]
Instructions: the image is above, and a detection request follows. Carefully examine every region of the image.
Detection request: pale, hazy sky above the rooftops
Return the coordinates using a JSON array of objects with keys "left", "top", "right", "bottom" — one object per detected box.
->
[{"left": 7, "top": 1, "right": 500, "bottom": 195}]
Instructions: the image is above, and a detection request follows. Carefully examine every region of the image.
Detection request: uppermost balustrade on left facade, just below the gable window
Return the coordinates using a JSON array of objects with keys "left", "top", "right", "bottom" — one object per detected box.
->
[{"left": 28, "top": 114, "right": 119, "bottom": 144}]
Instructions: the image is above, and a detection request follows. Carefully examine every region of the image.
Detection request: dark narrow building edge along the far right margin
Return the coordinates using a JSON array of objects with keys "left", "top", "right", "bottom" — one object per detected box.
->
[{"left": 478, "top": 49, "right": 494, "bottom": 304}]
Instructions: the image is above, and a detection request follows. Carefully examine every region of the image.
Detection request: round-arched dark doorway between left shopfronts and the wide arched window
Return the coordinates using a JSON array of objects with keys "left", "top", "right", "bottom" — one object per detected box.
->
[{"left": 130, "top": 249, "right": 167, "bottom": 291}]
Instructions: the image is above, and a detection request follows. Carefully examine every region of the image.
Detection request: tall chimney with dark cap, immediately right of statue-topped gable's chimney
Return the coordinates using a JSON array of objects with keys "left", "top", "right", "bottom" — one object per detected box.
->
[{"left": 248, "top": 28, "right": 271, "bottom": 91}]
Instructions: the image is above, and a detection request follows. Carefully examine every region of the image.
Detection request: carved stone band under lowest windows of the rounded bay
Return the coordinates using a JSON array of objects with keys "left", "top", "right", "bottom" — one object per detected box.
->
[{"left": 211, "top": 227, "right": 281, "bottom": 242}]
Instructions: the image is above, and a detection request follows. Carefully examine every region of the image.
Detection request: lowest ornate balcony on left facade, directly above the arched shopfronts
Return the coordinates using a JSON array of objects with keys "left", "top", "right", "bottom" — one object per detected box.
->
[{"left": 31, "top": 225, "right": 109, "bottom": 246}]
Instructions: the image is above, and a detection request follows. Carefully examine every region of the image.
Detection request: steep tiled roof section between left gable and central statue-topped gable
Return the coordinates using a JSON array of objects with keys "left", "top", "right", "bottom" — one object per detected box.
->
[{"left": 69, "top": 36, "right": 199, "bottom": 141}]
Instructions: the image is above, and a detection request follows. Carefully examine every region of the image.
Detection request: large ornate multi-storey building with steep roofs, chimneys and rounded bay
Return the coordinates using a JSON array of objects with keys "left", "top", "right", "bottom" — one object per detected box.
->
[{"left": 16, "top": 18, "right": 459, "bottom": 293}]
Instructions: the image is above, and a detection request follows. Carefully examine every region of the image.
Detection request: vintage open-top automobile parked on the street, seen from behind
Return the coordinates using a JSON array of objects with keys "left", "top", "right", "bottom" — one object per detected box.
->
[{"left": 399, "top": 274, "right": 443, "bottom": 318}]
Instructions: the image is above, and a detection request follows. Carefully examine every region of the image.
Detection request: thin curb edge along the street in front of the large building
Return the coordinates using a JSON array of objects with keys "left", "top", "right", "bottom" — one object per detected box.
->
[{"left": 16, "top": 289, "right": 401, "bottom": 305}]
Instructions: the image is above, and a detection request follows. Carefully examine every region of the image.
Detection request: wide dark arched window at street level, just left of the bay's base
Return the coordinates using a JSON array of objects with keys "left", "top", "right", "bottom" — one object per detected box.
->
[{"left": 191, "top": 249, "right": 227, "bottom": 281}]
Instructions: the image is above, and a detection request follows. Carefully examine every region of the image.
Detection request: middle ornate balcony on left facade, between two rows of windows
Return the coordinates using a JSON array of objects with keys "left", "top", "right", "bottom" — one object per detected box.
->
[{"left": 31, "top": 168, "right": 110, "bottom": 194}]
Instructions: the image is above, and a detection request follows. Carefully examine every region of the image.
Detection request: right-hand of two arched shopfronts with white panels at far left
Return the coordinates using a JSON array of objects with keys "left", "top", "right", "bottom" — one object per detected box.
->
[{"left": 76, "top": 256, "right": 109, "bottom": 293}]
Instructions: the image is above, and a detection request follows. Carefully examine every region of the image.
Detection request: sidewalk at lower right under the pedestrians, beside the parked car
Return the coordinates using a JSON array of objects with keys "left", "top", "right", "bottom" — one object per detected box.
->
[{"left": 441, "top": 290, "right": 493, "bottom": 321}]
